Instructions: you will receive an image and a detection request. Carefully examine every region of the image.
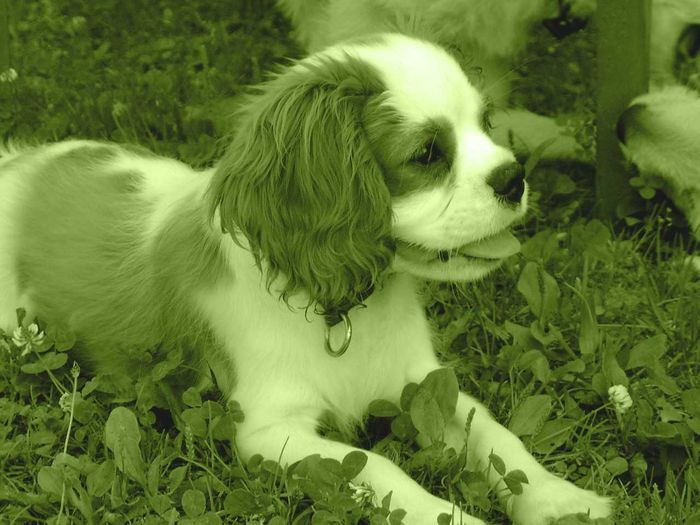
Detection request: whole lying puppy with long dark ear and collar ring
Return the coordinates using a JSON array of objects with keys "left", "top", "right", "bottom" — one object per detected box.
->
[{"left": 0, "top": 34, "right": 610, "bottom": 525}]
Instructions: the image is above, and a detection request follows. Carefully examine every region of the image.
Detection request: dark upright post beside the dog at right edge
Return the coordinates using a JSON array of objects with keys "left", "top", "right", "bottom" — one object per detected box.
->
[{"left": 596, "top": 0, "right": 651, "bottom": 219}]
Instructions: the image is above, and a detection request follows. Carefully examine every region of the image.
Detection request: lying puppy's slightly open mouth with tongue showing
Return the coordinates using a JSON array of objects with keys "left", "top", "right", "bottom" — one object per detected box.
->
[{"left": 396, "top": 230, "right": 520, "bottom": 265}]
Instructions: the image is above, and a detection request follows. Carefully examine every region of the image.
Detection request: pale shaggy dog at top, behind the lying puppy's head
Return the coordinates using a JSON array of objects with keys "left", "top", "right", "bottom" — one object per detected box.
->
[{"left": 277, "top": 0, "right": 595, "bottom": 158}]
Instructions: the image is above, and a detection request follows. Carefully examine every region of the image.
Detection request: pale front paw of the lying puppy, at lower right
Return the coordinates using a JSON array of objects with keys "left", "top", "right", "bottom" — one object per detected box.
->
[{"left": 508, "top": 475, "right": 612, "bottom": 525}]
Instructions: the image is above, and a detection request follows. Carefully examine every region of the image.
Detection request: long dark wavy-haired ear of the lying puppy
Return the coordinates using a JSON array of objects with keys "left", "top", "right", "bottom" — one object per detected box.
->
[{"left": 209, "top": 56, "right": 394, "bottom": 313}]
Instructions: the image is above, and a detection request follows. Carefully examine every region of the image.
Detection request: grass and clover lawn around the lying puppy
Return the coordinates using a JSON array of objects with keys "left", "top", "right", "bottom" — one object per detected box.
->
[{"left": 0, "top": 0, "right": 700, "bottom": 525}]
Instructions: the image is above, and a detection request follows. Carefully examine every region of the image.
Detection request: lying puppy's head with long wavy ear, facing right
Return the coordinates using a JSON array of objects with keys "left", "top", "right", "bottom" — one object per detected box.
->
[{"left": 209, "top": 34, "right": 527, "bottom": 318}]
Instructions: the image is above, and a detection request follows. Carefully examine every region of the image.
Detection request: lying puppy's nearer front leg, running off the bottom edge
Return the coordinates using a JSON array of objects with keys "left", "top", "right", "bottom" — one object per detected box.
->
[{"left": 236, "top": 414, "right": 484, "bottom": 525}]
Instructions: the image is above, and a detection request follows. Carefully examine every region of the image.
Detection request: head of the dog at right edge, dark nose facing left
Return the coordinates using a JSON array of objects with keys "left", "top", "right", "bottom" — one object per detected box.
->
[{"left": 617, "top": 86, "right": 700, "bottom": 231}]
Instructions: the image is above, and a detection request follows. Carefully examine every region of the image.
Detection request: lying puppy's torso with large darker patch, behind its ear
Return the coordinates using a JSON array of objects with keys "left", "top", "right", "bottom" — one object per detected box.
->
[{"left": 0, "top": 141, "right": 220, "bottom": 370}]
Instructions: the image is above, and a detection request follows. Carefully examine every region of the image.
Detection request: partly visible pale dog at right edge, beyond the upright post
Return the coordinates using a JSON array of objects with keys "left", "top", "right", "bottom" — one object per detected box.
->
[{"left": 617, "top": 0, "right": 700, "bottom": 234}]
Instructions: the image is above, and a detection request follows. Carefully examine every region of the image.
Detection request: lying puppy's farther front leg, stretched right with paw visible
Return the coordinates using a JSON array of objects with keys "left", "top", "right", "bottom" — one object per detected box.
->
[{"left": 419, "top": 393, "right": 610, "bottom": 525}]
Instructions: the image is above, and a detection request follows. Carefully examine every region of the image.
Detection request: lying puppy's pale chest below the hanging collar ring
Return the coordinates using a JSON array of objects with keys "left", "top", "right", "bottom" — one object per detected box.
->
[{"left": 198, "top": 266, "right": 435, "bottom": 420}]
